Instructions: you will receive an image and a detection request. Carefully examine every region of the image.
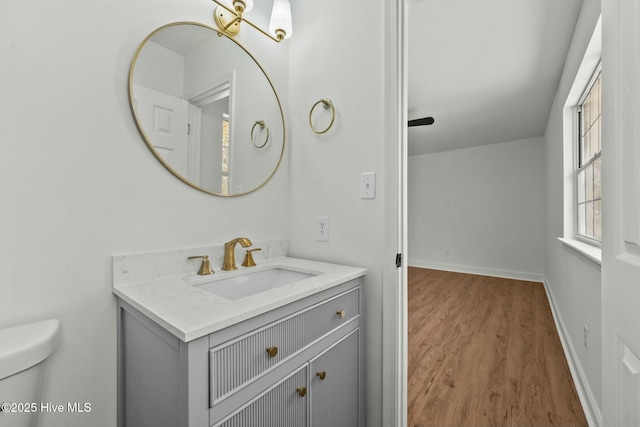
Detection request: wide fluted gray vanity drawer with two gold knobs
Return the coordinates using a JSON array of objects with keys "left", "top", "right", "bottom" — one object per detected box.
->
[{"left": 209, "top": 287, "right": 360, "bottom": 407}]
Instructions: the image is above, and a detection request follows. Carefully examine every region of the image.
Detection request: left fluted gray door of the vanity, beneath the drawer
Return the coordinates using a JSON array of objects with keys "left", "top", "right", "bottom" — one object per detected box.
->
[{"left": 215, "top": 365, "right": 309, "bottom": 427}]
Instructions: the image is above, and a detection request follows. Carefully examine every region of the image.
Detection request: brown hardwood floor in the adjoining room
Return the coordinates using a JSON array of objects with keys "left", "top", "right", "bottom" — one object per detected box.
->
[{"left": 408, "top": 267, "right": 587, "bottom": 427}]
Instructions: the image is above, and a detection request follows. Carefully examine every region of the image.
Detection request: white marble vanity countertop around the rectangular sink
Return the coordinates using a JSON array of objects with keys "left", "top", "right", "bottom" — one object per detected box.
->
[{"left": 113, "top": 257, "right": 366, "bottom": 342}]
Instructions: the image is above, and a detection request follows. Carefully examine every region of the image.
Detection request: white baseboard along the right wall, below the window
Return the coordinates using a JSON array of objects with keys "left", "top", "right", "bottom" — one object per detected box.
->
[{"left": 544, "top": 278, "right": 602, "bottom": 427}]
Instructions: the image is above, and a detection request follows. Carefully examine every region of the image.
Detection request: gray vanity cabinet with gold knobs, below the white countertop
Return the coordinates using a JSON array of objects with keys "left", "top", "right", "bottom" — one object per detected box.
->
[{"left": 119, "top": 278, "right": 364, "bottom": 427}]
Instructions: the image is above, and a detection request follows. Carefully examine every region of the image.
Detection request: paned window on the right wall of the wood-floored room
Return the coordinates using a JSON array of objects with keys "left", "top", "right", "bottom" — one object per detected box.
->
[{"left": 576, "top": 67, "right": 602, "bottom": 242}]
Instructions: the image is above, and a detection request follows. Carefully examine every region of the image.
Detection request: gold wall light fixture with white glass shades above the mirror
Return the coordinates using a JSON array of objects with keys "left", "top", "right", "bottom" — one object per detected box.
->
[{"left": 213, "top": 0, "right": 292, "bottom": 43}]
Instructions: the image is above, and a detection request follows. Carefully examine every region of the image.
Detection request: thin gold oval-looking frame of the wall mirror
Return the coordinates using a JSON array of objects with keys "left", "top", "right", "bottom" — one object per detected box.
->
[{"left": 129, "top": 21, "right": 287, "bottom": 197}]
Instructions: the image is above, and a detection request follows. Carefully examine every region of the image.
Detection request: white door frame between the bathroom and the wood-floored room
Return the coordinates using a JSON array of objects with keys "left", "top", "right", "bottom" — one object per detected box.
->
[{"left": 382, "top": 0, "right": 408, "bottom": 427}]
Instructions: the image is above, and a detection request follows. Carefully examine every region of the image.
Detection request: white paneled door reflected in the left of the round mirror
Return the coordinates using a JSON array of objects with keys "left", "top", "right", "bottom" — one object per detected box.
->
[{"left": 134, "top": 85, "right": 189, "bottom": 178}]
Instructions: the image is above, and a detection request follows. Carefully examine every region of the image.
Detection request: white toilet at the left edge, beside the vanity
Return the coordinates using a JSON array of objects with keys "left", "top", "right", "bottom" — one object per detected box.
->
[{"left": 0, "top": 319, "right": 60, "bottom": 427}]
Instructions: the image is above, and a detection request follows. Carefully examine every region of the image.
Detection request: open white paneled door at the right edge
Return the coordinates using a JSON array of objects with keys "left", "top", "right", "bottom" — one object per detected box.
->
[{"left": 602, "top": 0, "right": 640, "bottom": 427}]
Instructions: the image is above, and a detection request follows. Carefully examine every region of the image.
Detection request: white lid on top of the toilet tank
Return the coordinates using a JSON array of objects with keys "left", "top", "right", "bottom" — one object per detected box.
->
[{"left": 0, "top": 319, "right": 60, "bottom": 380}]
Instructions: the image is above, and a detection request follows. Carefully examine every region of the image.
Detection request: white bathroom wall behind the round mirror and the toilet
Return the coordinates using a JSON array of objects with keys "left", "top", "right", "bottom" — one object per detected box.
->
[{"left": 0, "top": 0, "right": 290, "bottom": 427}]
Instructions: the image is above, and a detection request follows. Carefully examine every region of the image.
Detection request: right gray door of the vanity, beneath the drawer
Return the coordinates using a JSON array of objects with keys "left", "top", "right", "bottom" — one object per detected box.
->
[{"left": 309, "top": 329, "right": 360, "bottom": 427}]
